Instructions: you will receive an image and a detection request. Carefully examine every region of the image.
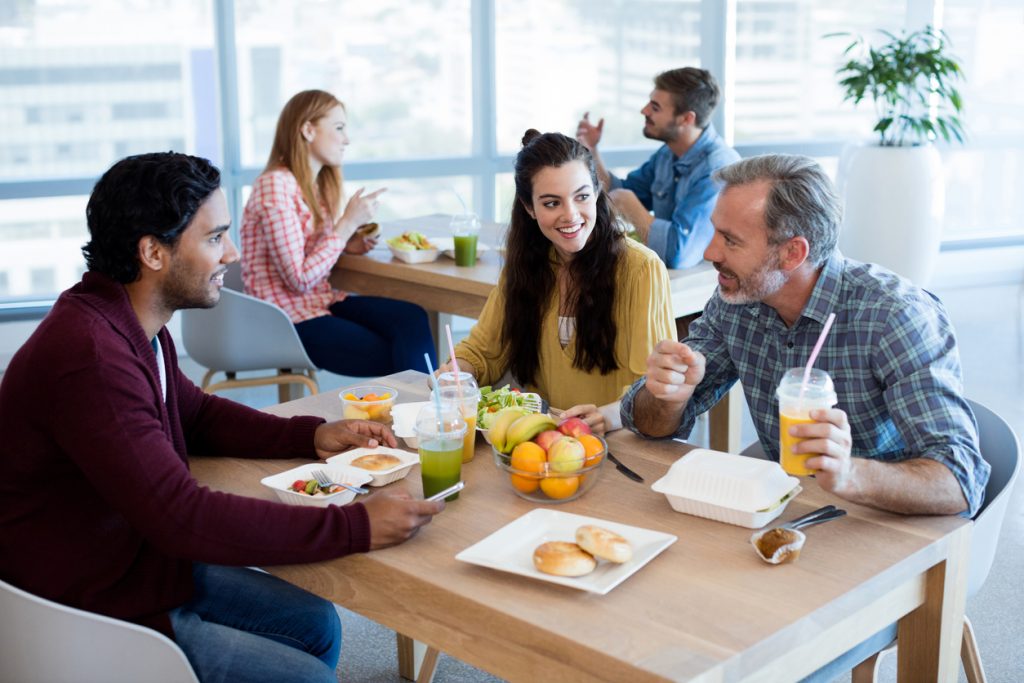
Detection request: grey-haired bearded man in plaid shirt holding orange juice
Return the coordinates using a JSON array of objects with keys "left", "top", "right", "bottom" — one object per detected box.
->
[{"left": 622, "top": 155, "right": 989, "bottom": 515}]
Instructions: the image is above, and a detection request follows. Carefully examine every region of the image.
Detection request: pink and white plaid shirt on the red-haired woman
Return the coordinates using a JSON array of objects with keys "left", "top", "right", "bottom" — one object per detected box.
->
[{"left": 241, "top": 169, "right": 345, "bottom": 323}]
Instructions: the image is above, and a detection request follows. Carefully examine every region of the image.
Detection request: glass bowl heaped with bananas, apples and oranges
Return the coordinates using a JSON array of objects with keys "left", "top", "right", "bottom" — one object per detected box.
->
[{"left": 490, "top": 408, "right": 608, "bottom": 503}]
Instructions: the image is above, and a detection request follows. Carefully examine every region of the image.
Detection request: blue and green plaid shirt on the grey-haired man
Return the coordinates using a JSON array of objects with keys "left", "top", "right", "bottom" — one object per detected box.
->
[{"left": 622, "top": 252, "right": 989, "bottom": 516}]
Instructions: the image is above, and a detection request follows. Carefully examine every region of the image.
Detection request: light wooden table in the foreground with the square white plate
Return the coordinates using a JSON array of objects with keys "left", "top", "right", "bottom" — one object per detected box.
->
[{"left": 193, "top": 373, "right": 972, "bottom": 682}]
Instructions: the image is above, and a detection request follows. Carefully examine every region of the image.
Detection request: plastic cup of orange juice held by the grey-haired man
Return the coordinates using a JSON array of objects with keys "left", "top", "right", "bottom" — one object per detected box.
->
[{"left": 775, "top": 368, "right": 839, "bottom": 476}]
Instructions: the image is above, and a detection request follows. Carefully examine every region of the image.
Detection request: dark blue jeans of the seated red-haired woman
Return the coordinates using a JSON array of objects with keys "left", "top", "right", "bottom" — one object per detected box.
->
[{"left": 295, "top": 294, "right": 437, "bottom": 377}]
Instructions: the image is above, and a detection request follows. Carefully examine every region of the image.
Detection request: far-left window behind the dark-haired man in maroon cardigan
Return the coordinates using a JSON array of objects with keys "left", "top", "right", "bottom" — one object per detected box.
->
[{"left": 0, "top": 0, "right": 219, "bottom": 298}]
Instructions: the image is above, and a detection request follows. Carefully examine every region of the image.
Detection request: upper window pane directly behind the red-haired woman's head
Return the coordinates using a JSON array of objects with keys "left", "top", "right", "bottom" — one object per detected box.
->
[{"left": 236, "top": 0, "right": 473, "bottom": 167}]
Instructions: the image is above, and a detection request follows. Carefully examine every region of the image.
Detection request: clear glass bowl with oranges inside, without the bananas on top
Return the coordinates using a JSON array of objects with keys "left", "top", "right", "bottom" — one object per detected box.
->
[{"left": 490, "top": 434, "right": 608, "bottom": 504}]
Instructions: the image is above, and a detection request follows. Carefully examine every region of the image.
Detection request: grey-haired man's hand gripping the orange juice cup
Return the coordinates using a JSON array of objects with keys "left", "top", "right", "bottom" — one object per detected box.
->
[{"left": 790, "top": 408, "right": 856, "bottom": 498}]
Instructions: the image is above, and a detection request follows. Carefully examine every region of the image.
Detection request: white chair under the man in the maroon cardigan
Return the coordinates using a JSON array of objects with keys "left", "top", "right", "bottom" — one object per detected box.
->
[{"left": 0, "top": 581, "right": 199, "bottom": 683}]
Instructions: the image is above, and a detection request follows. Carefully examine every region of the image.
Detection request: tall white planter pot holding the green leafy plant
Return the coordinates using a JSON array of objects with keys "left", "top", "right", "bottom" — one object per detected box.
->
[{"left": 837, "top": 144, "right": 945, "bottom": 287}]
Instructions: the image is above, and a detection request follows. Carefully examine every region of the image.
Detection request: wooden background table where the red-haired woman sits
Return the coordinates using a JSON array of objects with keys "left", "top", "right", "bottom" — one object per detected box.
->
[{"left": 331, "top": 214, "right": 743, "bottom": 453}]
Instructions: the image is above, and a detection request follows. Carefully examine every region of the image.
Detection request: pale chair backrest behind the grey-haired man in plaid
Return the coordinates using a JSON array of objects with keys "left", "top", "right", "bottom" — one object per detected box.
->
[{"left": 967, "top": 399, "right": 1021, "bottom": 597}]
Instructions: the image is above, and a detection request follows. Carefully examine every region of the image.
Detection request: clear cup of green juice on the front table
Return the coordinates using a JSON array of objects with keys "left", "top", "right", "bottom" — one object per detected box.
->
[{"left": 416, "top": 402, "right": 466, "bottom": 501}]
